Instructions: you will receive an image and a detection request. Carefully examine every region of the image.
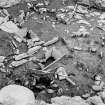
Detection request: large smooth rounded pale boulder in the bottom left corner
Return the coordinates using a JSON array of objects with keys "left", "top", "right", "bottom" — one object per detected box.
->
[{"left": 0, "top": 84, "right": 35, "bottom": 105}]
